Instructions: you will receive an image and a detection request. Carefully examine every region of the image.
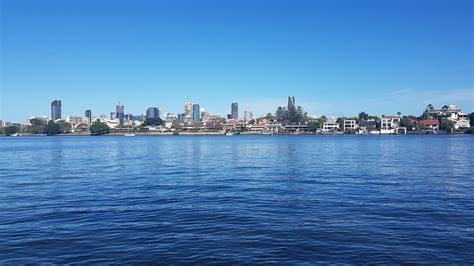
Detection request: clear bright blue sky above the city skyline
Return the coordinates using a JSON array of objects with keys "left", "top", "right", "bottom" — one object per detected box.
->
[{"left": 0, "top": 0, "right": 474, "bottom": 122}]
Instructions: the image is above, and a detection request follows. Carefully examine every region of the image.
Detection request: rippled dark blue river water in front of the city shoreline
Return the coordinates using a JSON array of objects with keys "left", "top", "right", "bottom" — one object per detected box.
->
[{"left": 0, "top": 136, "right": 474, "bottom": 265}]
